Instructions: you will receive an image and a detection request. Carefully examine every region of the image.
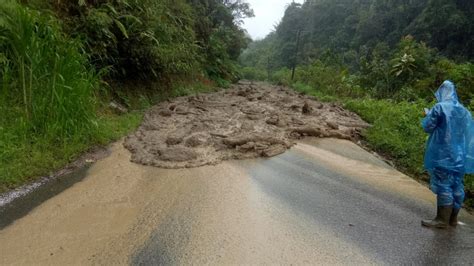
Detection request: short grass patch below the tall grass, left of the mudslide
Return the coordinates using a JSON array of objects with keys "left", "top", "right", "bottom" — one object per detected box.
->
[{"left": 0, "top": 111, "right": 142, "bottom": 193}]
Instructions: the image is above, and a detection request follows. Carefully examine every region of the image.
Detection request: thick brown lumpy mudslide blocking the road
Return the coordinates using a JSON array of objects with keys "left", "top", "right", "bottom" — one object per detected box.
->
[{"left": 124, "top": 81, "right": 368, "bottom": 168}]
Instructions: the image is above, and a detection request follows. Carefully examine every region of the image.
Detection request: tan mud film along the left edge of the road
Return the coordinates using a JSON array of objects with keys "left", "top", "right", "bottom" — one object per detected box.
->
[{"left": 0, "top": 144, "right": 148, "bottom": 265}]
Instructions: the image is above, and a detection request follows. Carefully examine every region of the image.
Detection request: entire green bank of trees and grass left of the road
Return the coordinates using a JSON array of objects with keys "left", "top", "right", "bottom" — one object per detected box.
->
[{"left": 0, "top": 0, "right": 253, "bottom": 191}]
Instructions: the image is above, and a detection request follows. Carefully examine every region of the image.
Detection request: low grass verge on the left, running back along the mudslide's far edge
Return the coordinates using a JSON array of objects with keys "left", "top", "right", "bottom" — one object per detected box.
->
[{"left": 0, "top": 81, "right": 217, "bottom": 193}]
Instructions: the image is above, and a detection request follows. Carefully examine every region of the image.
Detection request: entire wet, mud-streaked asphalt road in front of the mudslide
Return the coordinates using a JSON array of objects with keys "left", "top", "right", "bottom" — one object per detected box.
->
[{"left": 0, "top": 139, "right": 474, "bottom": 265}]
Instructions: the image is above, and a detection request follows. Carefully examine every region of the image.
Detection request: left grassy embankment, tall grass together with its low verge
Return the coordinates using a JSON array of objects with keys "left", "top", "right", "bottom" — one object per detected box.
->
[{"left": 0, "top": 1, "right": 217, "bottom": 193}]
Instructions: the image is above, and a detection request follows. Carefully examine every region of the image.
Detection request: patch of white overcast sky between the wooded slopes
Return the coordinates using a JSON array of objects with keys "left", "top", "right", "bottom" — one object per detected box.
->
[{"left": 244, "top": 0, "right": 304, "bottom": 40}]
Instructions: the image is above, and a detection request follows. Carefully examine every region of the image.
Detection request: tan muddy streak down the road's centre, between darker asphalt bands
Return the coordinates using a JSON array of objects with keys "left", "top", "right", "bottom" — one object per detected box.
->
[{"left": 131, "top": 158, "right": 376, "bottom": 265}]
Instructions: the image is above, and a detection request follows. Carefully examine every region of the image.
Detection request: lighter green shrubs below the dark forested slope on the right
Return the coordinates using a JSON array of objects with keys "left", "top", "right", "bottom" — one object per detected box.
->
[{"left": 240, "top": 35, "right": 474, "bottom": 105}]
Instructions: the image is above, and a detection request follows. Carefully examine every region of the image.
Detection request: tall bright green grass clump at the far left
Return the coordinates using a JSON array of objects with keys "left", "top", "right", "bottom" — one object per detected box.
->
[{"left": 0, "top": 1, "right": 99, "bottom": 138}]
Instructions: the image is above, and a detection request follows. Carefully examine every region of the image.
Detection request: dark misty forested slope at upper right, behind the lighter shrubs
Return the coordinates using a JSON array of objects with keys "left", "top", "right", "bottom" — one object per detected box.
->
[{"left": 244, "top": 0, "right": 474, "bottom": 70}]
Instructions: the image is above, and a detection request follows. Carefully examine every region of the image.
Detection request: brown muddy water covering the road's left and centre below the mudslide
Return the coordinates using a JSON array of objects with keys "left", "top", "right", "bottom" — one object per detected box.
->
[{"left": 0, "top": 140, "right": 378, "bottom": 265}]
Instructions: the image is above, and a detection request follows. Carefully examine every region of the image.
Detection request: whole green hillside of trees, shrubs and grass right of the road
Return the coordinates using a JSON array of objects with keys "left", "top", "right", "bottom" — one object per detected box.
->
[{"left": 240, "top": 0, "right": 474, "bottom": 206}]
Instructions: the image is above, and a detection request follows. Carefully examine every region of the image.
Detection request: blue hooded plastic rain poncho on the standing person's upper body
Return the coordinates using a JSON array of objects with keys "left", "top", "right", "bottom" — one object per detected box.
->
[{"left": 422, "top": 81, "right": 474, "bottom": 175}]
